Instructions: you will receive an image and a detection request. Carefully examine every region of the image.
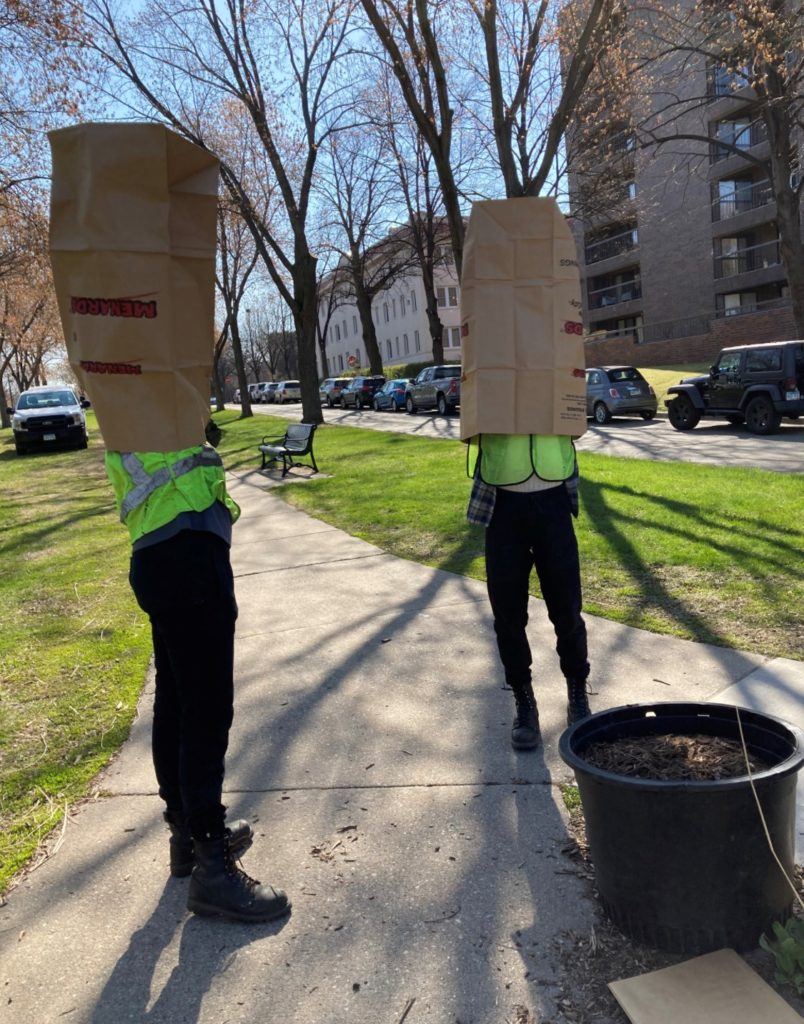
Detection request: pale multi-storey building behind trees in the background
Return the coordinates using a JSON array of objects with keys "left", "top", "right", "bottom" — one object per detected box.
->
[{"left": 319, "top": 250, "right": 461, "bottom": 377}]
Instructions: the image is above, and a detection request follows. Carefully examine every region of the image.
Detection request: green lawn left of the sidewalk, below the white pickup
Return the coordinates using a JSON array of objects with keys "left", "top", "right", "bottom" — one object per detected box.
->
[{"left": 0, "top": 419, "right": 151, "bottom": 892}]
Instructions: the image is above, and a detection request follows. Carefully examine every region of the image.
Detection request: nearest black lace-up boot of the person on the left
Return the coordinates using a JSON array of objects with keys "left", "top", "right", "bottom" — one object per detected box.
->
[{"left": 187, "top": 836, "right": 291, "bottom": 921}]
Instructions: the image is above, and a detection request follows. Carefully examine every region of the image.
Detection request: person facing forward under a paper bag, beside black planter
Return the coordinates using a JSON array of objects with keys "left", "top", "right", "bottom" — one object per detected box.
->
[{"left": 461, "top": 199, "right": 590, "bottom": 750}]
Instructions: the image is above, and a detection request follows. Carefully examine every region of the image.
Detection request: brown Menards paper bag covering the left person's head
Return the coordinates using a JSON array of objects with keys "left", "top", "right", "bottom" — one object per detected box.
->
[{"left": 49, "top": 124, "right": 218, "bottom": 452}]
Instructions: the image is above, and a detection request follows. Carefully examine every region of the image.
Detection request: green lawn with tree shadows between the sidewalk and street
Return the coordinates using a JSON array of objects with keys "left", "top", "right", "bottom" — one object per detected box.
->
[{"left": 217, "top": 413, "right": 804, "bottom": 658}]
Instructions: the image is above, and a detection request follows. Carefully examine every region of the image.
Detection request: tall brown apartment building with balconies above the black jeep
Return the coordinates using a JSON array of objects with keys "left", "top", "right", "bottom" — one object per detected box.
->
[{"left": 569, "top": 37, "right": 802, "bottom": 365}]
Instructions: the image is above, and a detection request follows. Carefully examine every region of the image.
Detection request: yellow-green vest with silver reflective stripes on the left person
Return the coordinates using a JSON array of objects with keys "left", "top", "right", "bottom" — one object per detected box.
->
[{"left": 105, "top": 444, "right": 240, "bottom": 543}]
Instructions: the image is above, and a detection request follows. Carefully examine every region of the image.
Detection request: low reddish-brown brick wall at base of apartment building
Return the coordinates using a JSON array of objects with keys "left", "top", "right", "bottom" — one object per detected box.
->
[{"left": 585, "top": 309, "right": 796, "bottom": 367}]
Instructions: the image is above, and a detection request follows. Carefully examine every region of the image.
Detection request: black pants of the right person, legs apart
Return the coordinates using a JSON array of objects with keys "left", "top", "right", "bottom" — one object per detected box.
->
[{"left": 485, "top": 486, "right": 589, "bottom": 692}]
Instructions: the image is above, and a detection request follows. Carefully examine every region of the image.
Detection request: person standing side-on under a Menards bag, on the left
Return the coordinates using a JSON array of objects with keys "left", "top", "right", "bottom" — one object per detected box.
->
[{"left": 50, "top": 124, "right": 290, "bottom": 922}]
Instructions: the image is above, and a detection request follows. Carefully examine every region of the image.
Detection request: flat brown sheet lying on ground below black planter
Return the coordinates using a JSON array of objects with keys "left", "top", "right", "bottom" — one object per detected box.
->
[{"left": 608, "top": 949, "right": 802, "bottom": 1024}]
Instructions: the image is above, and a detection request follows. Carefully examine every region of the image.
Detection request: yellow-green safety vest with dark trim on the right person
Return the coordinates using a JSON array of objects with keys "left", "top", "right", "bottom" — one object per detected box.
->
[{"left": 467, "top": 434, "right": 576, "bottom": 487}]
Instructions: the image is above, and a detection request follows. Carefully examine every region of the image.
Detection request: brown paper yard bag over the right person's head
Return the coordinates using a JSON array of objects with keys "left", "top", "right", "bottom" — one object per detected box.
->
[{"left": 461, "top": 199, "right": 586, "bottom": 440}]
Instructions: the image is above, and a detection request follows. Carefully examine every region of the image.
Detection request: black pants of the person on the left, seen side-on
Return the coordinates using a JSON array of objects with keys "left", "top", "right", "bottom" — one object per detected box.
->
[{"left": 129, "top": 530, "right": 238, "bottom": 838}]
